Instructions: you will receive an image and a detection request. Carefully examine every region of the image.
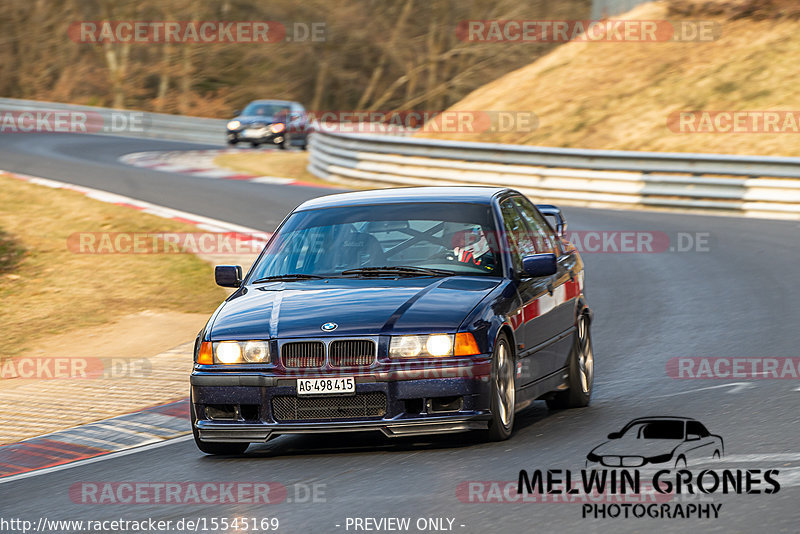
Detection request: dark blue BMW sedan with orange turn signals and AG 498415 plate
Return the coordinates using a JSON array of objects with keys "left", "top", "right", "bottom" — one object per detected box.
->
[{"left": 191, "top": 187, "right": 594, "bottom": 454}]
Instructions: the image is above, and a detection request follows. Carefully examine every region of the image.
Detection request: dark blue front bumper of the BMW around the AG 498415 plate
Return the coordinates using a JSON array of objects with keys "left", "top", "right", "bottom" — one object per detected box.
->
[{"left": 191, "top": 358, "right": 491, "bottom": 442}]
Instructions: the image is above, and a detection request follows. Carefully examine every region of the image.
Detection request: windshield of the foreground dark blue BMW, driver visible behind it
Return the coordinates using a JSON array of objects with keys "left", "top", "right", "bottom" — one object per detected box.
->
[{"left": 250, "top": 203, "right": 500, "bottom": 280}]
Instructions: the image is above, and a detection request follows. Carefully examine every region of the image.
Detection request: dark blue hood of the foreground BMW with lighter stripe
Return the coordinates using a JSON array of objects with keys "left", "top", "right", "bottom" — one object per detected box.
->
[{"left": 211, "top": 277, "right": 500, "bottom": 340}]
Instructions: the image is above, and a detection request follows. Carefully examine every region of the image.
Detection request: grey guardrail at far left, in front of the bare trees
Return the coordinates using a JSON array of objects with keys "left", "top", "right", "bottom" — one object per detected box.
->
[{"left": 0, "top": 98, "right": 226, "bottom": 145}]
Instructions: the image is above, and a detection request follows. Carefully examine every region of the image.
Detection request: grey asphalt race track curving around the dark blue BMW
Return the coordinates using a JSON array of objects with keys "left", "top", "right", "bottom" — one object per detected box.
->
[{"left": 0, "top": 134, "right": 800, "bottom": 533}]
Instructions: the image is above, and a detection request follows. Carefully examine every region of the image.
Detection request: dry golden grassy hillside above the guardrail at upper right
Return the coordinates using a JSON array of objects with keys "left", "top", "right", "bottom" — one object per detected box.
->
[{"left": 420, "top": 0, "right": 800, "bottom": 156}]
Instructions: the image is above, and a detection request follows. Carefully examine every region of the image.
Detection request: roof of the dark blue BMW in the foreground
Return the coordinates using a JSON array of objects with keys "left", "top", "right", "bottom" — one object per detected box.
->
[{"left": 295, "top": 186, "right": 512, "bottom": 211}]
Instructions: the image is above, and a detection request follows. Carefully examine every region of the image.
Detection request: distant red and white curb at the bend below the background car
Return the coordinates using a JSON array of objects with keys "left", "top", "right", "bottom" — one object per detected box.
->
[{"left": 119, "top": 148, "right": 330, "bottom": 187}]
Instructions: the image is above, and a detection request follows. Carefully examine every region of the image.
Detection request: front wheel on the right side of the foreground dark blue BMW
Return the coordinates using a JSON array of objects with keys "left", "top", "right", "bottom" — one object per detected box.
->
[{"left": 484, "top": 334, "right": 516, "bottom": 441}]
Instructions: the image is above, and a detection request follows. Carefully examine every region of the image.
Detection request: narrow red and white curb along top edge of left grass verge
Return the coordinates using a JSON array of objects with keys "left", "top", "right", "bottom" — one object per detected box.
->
[{"left": 0, "top": 169, "right": 271, "bottom": 247}]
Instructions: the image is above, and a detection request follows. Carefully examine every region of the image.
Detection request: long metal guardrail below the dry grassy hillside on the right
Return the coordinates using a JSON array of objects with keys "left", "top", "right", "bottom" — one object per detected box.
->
[{"left": 308, "top": 130, "right": 800, "bottom": 218}]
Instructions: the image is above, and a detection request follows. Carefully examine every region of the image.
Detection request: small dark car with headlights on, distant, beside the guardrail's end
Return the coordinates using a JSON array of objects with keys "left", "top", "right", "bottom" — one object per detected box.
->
[{"left": 226, "top": 100, "right": 311, "bottom": 150}]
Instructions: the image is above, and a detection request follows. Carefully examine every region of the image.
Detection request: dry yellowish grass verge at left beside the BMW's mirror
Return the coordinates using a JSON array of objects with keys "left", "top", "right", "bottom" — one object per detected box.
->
[{"left": 0, "top": 175, "right": 225, "bottom": 355}]
